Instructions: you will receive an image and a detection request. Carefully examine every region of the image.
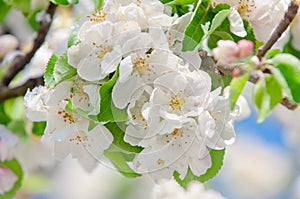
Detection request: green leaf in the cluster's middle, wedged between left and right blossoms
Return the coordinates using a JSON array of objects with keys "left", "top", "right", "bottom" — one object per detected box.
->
[{"left": 97, "top": 70, "right": 128, "bottom": 122}]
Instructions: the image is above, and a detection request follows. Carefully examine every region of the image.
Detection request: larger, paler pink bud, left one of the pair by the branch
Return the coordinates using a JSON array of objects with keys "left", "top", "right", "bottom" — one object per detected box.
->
[{"left": 212, "top": 40, "right": 239, "bottom": 63}]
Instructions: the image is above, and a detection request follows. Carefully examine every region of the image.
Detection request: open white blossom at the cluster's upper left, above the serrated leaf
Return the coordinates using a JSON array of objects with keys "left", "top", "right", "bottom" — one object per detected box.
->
[{"left": 68, "top": 22, "right": 132, "bottom": 81}]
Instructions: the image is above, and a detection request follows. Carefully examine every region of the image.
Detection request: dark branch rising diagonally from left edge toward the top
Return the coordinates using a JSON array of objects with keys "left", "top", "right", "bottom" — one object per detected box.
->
[{"left": 0, "top": 2, "right": 57, "bottom": 88}]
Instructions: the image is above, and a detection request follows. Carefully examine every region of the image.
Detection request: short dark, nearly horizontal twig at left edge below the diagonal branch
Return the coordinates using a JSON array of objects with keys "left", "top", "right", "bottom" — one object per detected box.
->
[{"left": 0, "top": 77, "right": 44, "bottom": 102}]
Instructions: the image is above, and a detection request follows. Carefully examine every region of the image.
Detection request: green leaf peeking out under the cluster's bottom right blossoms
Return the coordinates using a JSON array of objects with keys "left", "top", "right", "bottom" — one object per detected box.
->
[{"left": 173, "top": 149, "right": 225, "bottom": 189}]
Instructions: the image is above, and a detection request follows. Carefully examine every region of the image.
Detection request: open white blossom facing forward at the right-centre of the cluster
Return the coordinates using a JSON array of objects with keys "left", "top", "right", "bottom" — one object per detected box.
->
[{"left": 144, "top": 71, "right": 211, "bottom": 134}]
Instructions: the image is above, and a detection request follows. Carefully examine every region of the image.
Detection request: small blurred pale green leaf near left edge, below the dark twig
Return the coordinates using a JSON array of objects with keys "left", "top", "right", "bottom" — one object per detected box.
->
[{"left": 4, "top": 97, "right": 25, "bottom": 120}]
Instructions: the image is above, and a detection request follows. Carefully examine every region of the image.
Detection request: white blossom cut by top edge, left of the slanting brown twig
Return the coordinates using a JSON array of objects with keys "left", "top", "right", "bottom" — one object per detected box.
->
[{"left": 212, "top": 0, "right": 290, "bottom": 42}]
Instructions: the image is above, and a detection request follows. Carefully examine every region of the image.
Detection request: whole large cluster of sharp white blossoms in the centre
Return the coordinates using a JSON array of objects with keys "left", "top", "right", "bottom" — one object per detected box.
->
[{"left": 25, "top": 0, "right": 241, "bottom": 179}]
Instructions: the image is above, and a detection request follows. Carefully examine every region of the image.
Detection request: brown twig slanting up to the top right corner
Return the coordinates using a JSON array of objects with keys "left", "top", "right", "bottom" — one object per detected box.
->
[{"left": 256, "top": 0, "right": 299, "bottom": 59}]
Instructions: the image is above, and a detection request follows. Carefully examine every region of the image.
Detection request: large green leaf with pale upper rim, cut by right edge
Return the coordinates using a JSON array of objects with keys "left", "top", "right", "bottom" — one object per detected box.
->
[{"left": 271, "top": 53, "right": 300, "bottom": 103}]
